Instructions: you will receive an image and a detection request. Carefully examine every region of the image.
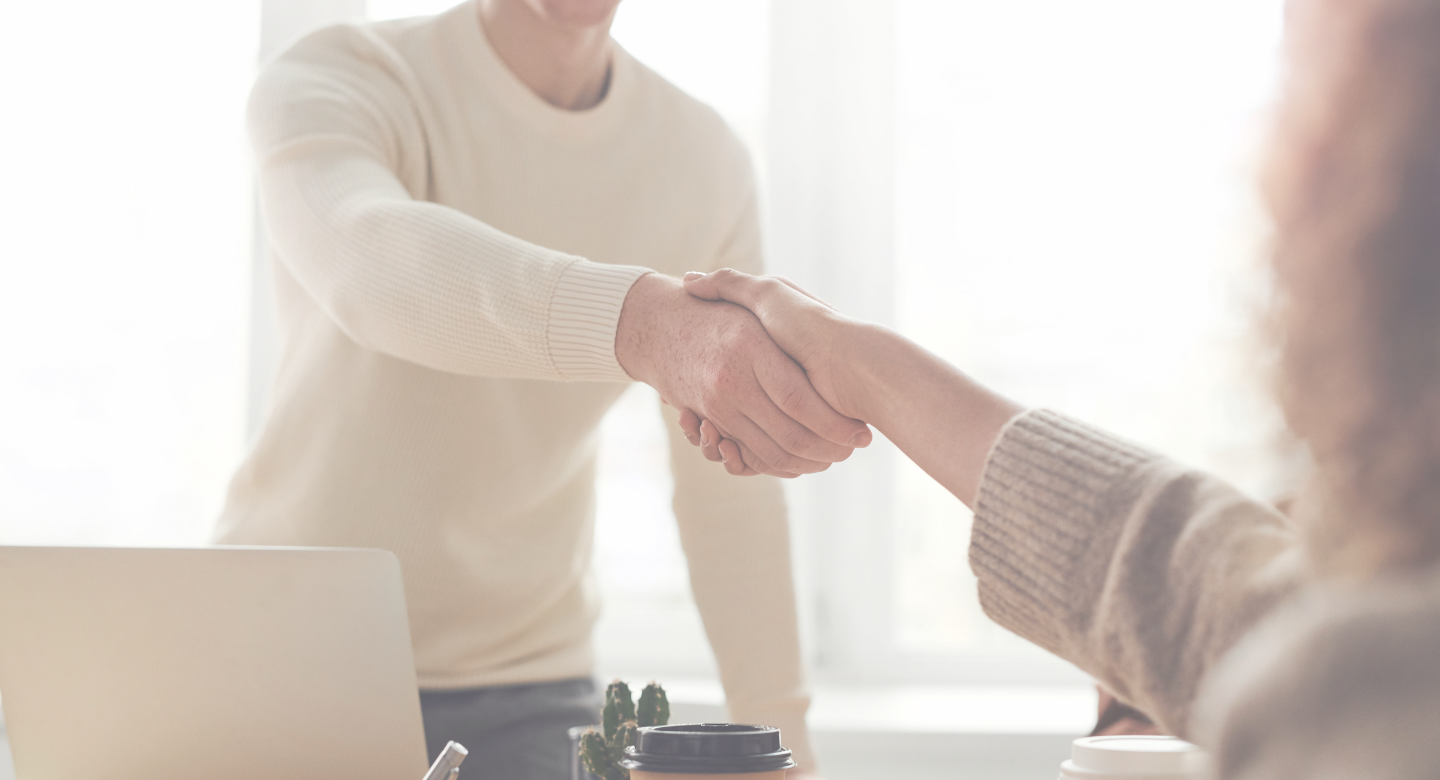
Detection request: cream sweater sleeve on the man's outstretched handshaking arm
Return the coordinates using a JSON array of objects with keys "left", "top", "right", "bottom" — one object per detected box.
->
[{"left": 249, "top": 26, "right": 649, "bottom": 381}]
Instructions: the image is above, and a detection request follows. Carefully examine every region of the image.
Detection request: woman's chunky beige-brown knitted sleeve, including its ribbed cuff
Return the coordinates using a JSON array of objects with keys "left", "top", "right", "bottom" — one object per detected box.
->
[{"left": 971, "top": 412, "right": 1303, "bottom": 737}]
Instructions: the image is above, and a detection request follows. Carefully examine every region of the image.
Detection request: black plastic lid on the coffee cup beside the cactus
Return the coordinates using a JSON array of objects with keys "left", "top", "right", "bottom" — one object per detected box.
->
[{"left": 621, "top": 722, "right": 795, "bottom": 774}]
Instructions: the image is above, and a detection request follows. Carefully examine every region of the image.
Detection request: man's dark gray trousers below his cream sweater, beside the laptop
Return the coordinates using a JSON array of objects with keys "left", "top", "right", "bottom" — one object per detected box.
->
[{"left": 420, "top": 679, "right": 603, "bottom": 780}]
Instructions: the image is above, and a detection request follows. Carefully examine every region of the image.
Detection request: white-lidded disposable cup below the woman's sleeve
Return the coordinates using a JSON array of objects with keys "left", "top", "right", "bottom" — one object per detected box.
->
[{"left": 1060, "top": 737, "right": 1210, "bottom": 780}]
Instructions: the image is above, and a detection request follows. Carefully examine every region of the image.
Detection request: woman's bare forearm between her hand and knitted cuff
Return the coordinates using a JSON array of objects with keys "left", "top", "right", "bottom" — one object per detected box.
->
[{"left": 835, "top": 321, "right": 1024, "bottom": 508}]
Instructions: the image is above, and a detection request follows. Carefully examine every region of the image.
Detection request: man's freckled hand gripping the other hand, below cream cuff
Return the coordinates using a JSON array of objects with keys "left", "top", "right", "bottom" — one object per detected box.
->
[{"left": 615, "top": 273, "right": 871, "bottom": 476}]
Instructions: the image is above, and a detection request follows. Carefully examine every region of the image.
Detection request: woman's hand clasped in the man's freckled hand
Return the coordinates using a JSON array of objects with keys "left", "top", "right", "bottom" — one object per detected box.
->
[{"left": 680, "top": 269, "right": 871, "bottom": 476}]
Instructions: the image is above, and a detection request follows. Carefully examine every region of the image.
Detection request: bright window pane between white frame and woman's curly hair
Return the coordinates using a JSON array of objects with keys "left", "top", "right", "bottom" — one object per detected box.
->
[{"left": 891, "top": 0, "right": 1284, "bottom": 679}]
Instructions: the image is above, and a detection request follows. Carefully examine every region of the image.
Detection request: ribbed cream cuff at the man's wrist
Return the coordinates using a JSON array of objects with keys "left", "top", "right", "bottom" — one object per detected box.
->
[{"left": 547, "top": 260, "right": 654, "bottom": 381}]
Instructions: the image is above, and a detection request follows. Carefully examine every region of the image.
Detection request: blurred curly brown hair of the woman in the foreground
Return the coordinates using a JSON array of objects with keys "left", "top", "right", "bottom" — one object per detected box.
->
[{"left": 1266, "top": 0, "right": 1440, "bottom": 576}]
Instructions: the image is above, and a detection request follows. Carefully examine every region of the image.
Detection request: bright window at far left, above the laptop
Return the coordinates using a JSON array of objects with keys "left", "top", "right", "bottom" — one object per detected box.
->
[{"left": 0, "top": 0, "right": 259, "bottom": 544}]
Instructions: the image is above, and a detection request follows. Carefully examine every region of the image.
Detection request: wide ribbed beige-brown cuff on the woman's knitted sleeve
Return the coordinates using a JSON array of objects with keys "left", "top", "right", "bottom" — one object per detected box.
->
[{"left": 971, "top": 410, "right": 1159, "bottom": 655}]
